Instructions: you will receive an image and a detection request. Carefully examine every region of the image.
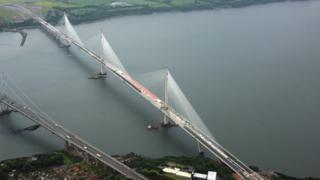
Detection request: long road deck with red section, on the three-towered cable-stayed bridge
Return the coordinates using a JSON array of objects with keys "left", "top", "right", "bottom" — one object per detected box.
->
[{"left": 33, "top": 13, "right": 263, "bottom": 180}]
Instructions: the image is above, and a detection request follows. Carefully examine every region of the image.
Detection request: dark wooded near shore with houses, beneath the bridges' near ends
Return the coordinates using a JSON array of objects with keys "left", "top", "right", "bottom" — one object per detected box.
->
[{"left": 0, "top": 150, "right": 320, "bottom": 180}]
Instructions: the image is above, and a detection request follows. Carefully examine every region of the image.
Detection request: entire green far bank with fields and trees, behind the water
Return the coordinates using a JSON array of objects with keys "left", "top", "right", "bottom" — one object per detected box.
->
[{"left": 0, "top": 0, "right": 303, "bottom": 28}]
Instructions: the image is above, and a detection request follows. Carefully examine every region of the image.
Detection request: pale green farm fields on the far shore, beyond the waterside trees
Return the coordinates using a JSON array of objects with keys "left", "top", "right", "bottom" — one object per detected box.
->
[{"left": 0, "top": 0, "right": 205, "bottom": 23}]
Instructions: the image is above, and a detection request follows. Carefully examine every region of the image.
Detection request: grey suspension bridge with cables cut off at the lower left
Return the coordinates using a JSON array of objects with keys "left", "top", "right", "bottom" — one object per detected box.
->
[{"left": 0, "top": 75, "right": 146, "bottom": 180}]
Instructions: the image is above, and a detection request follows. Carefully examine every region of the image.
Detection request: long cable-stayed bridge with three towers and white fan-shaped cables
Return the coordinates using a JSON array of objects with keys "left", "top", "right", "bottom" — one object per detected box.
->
[{"left": 3, "top": 5, "right": 263, "bottom": 180}]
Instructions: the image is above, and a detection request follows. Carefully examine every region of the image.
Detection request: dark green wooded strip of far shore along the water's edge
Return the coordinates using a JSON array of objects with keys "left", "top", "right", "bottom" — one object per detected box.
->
[{"left": 0, "top": 0, "right": 311, "bottom": 32}]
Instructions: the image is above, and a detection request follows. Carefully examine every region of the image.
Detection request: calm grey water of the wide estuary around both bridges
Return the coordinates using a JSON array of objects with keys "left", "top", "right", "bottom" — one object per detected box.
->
[{"left": 0, "top": 1, "right": 320, "bottom": 177}]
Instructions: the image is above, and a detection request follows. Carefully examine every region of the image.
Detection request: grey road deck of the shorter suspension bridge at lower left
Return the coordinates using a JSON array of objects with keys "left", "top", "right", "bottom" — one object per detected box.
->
[{"left": 0, "top": 96, "right": 146, "bottom": 180}]
